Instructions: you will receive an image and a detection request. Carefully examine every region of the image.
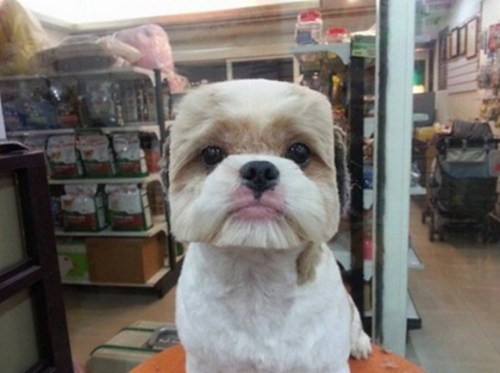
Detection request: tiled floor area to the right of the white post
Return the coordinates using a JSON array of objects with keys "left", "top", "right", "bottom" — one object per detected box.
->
[{"left": 409, "top": 203, "right": 500, "bottom": 373}]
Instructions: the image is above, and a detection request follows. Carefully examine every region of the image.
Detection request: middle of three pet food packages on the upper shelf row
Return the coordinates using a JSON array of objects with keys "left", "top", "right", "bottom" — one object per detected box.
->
[{"left": 78, "top": 135, "right": 116, "bottom": 177}]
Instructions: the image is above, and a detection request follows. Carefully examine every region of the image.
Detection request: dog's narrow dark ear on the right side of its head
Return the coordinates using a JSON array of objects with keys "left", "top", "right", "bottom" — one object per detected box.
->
[{"left": 333, "top": 126, "right": 351, "bottom": 216}]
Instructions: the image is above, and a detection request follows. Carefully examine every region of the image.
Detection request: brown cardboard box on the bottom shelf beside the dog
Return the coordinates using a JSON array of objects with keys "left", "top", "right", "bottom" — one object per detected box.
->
[{"left": 87, "top": 233, "right": 165, "bottom": 284}]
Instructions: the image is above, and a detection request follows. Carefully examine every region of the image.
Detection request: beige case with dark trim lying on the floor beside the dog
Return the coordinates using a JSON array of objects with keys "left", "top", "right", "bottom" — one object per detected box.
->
[{"left": 87, "top": 321, "right": 179, "bottom": 373}]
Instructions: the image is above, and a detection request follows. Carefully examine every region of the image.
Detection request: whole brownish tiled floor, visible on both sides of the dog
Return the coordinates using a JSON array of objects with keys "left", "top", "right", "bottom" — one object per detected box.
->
[{"left": 66, "top": 203, "right": 500, "bottom": 373}]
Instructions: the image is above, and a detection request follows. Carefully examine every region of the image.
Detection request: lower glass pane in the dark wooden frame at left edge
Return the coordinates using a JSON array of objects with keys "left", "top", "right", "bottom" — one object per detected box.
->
[{"left": 0, "top": 291, "right": 40, "bottom": 372}]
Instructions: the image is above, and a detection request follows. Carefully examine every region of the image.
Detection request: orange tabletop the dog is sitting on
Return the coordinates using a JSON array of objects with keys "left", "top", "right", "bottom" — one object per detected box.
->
[{"left": 130, "top": 345, "right": 424, "bottom": 373}]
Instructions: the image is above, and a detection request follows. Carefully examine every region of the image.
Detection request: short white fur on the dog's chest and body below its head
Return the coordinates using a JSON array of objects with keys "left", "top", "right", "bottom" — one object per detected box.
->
[{"left": 177, "top": 244, "right": 354, "bottom": 373}]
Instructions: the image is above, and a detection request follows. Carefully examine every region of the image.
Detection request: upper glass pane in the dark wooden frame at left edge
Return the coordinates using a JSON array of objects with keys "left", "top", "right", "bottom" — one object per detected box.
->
[{"left": 0, "top": 174, "right": 26, "bottom": 271}]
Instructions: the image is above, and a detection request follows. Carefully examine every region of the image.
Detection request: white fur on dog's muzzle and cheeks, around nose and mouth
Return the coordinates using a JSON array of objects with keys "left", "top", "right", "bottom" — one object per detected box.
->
[{"left": 171, "top": 154, "right": 332, "bottom": 249}]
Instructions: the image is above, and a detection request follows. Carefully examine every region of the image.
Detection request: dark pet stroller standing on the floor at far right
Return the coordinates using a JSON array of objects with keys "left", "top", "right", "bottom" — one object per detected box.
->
[{"left": 422, "top": 121, "right": 500, "bottom": 242}]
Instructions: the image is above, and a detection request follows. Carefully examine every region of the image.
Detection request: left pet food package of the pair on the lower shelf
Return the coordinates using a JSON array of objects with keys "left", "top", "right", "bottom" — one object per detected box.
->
[{"left": 61, "top": 184, "right": 106, "bottom": 232}]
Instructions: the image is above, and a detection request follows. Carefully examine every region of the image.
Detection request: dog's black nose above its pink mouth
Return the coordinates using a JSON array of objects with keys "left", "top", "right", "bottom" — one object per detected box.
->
[{"left": 240, "top": 161, "right": 280, "bottom": 198}]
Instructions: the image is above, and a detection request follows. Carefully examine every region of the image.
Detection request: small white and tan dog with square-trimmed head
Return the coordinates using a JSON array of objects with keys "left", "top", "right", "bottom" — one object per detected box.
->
[{"left": 169, "top": 80, "right": 371, "bottom": 373}]
